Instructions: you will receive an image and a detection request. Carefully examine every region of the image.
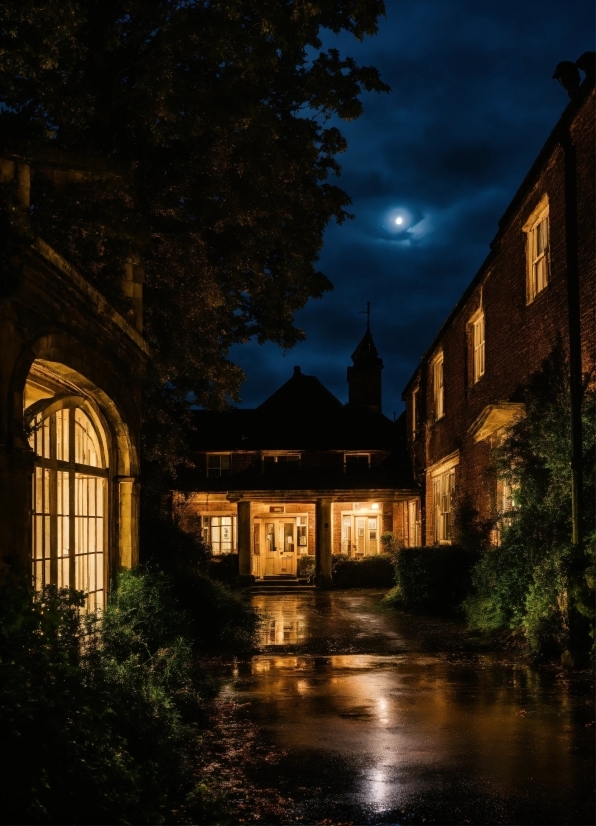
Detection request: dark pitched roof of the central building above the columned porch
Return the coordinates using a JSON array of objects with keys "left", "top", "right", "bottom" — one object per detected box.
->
[{"left": 179, "top": 368, "right": 415, "bottom": 491}]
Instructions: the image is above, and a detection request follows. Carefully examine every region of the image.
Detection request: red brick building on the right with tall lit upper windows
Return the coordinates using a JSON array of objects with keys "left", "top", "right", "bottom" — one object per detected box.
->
[{"left": 403, "top": 55, "right": 596, "bottom": 544}]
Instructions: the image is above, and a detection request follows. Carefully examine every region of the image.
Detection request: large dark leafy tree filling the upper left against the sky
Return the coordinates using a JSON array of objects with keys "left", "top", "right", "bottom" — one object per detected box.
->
[{"left": 0, "top": 0, "right": 388, "bottom": 480}]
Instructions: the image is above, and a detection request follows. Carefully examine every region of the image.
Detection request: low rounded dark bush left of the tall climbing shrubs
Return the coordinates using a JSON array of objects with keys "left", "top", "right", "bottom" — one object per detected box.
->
[{"left": 386, "top": 545, "right": 478, "bottom": 614}]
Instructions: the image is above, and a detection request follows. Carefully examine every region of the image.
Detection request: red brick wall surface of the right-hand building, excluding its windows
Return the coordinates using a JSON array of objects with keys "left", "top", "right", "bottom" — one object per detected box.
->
[{"left": 405, "top": 87, "right": 596, "bottom": 544}]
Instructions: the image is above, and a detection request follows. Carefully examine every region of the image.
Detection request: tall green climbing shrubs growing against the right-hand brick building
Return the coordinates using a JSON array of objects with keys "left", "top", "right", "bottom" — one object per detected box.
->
[{"left": 465, "top": 345, "right": 595, "bottom": 658}]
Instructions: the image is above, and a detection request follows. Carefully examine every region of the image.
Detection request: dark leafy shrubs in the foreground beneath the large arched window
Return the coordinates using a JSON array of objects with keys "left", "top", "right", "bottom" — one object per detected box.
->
[{"left": 0, "top": 568, "right": 255, "bottom": 823}]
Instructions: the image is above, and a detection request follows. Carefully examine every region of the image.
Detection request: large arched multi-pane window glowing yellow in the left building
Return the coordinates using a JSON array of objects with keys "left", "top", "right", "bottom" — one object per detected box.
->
[{"left": 29, "top": 402, "right": 108, "bottom": 611}]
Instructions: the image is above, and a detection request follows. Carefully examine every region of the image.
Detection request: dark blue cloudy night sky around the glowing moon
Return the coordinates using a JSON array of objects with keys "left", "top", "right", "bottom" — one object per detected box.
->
[{"left": 231, "top": 0, "right": 594, "bottom": 417}]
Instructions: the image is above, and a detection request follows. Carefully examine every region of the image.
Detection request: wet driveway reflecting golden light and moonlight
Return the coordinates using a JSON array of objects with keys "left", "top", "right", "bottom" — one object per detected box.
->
[{"left": 213, "top": 591, "right": 594, "bottom": 824}]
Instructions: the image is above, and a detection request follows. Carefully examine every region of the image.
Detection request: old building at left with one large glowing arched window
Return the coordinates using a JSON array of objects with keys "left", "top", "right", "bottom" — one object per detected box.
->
[{"left": 0, "top": 148, "right": 148, "bottom": 609}]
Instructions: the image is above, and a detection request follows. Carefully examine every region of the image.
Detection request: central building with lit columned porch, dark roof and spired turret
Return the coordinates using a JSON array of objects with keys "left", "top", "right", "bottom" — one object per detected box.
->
[{"left": 175, "top": 329, "right": 418, "bottom": 584}]
